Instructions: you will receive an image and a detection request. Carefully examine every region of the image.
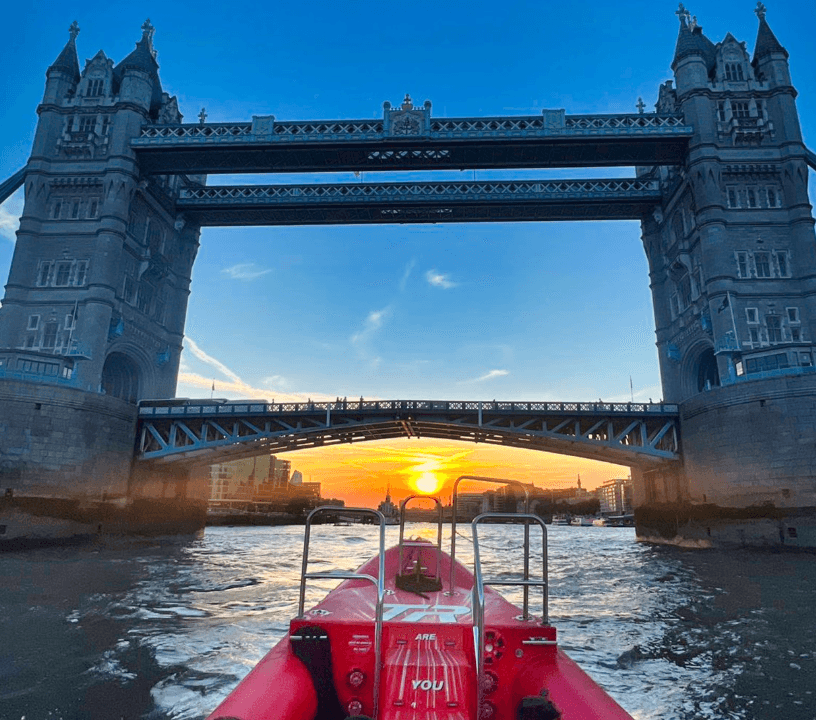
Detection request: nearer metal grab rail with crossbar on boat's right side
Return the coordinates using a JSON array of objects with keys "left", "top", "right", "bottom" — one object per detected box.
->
[{"left": 471, "top": 513, "right": 549, "bottom": 696}]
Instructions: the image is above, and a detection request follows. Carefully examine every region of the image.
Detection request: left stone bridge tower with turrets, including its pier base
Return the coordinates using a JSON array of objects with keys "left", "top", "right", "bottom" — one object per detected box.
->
[{"left": 0, "top": 21, "right": 205, "bottom": 543}]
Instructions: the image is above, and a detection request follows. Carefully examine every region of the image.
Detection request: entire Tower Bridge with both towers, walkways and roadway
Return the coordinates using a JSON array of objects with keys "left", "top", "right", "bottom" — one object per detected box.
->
[{"left": 0, "top": 3, "right": 816, "bottom": 546}]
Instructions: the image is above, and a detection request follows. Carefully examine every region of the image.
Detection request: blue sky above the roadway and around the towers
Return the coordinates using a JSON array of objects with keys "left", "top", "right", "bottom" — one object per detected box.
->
[{"left": 0, "top": 0, "right": 816, "bottom": 496}]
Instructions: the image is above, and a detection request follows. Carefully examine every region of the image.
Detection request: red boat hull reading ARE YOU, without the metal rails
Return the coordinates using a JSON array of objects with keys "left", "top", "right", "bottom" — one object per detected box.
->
[{"left": 210, "top": 544, "right": 632, "bottom": 720}]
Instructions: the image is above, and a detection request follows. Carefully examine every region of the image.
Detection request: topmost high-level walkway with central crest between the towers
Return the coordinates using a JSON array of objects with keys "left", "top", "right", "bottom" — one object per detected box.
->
[{"left": 131, "top": 109, "right": 693, "bottom": 173}]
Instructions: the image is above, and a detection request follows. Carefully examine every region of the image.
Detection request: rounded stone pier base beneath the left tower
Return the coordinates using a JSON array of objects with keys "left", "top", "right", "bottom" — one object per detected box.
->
[{"left": 0, "top": 379, "right": 207, "bottom": 549}]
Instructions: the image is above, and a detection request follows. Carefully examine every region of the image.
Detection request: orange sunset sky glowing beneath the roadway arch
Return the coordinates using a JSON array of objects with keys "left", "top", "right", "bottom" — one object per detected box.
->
[{"left": 281, "top": 439, "right": 629, "bottom": 507}]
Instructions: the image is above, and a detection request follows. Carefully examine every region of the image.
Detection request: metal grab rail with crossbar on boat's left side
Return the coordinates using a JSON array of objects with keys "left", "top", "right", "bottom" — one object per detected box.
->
[{"left": 298, "top": 506, "right": 385, "bottom": 720}]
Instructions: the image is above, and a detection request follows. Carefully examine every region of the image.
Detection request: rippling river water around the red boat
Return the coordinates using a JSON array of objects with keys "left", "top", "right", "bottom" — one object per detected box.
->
[{"left": 0, "top": 524, "right": 816, "bottom": 720}]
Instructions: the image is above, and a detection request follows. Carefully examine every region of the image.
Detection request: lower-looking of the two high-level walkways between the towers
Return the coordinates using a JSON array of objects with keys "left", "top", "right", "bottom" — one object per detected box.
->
[{"left": 176, "top": 178, "right": 661, "bottom": 226}]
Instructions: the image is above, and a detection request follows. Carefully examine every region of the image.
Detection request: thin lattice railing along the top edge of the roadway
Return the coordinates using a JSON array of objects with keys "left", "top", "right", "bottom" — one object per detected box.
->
[{"left": 139, "top": 399, "right": 678, "bottom": 417}]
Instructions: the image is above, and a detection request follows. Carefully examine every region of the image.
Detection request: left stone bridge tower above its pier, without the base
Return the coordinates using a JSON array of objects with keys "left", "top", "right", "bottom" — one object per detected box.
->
[{"left": 0, "top": 21, "right": 199, "bottom": 402}]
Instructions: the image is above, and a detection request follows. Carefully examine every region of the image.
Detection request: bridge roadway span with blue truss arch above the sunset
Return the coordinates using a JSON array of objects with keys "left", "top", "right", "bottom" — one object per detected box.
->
[{"left": 136, "top": 398, "right": 680, "bottom": 469}]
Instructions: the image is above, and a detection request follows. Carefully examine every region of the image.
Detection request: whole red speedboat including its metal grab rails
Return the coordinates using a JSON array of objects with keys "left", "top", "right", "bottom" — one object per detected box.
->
[{"left": 209, "top": 476, "right": 632, "bottom": 720}]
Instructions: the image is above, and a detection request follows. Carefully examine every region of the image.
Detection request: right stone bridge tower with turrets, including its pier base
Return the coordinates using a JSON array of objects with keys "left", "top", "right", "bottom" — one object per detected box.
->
[{"left": 638, "top": 3, "right": 816, "bottom": 544}]
